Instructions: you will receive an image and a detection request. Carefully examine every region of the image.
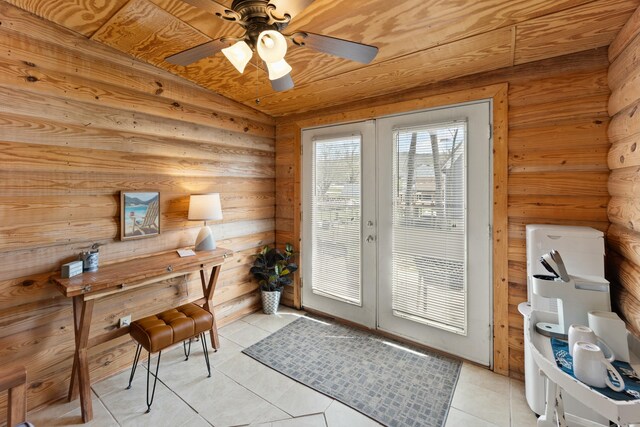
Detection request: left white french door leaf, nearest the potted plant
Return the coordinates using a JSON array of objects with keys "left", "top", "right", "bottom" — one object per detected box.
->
[{"left": 302, "top": 121, "right": 376, "bottom": 328}]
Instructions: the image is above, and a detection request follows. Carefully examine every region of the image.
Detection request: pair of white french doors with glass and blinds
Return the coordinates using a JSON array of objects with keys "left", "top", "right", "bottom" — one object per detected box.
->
[{"left": 302, "top": 101, "right": 492, "bottom": 365}]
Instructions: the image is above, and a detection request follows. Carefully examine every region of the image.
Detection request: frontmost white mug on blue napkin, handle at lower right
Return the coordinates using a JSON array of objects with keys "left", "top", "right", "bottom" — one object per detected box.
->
[{"left": 573, "top": 341, "right": 624, "bottom": 391}]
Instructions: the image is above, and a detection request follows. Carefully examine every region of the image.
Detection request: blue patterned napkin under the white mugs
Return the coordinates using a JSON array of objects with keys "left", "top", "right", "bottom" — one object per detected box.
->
[{"left": 551, "top": 338, "right": 640, "bottom": 400}]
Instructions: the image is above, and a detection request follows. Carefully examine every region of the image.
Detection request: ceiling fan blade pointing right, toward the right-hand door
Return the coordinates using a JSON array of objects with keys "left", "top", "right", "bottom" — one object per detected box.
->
[{"left": 288, "top": 31, "right": 378, "bottom": 64}]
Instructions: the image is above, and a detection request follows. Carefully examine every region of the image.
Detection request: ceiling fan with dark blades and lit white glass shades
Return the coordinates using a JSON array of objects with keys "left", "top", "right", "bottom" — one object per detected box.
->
[{"left": 165, "top": 0, "right": 378, "bottom": 91}]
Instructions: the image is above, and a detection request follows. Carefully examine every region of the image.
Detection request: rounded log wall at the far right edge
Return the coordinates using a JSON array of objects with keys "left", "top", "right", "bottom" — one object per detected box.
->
[{"left": 607, "top": 5, "right": 640, "bottom": 334}]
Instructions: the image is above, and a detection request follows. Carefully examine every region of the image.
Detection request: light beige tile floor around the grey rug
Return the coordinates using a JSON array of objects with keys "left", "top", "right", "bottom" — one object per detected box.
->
[{"left": 29, "top": 308, "right": 536, "bottom": 427}]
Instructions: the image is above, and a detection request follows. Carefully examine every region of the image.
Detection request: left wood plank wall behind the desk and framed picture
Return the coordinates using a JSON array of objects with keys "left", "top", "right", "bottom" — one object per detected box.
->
[{"left": 0, "top": 2, "right": 275, "bottom": 419}]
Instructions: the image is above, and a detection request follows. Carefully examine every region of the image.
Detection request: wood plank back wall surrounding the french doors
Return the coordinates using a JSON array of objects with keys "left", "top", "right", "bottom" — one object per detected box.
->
[{"left": 276, "top": 48, "right": 609, "bottom": 378}]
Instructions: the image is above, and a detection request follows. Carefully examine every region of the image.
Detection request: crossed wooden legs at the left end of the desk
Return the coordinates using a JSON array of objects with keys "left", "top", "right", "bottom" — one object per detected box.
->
[{"left": 69, "top": 295, "right": 93, "bottom": 423}]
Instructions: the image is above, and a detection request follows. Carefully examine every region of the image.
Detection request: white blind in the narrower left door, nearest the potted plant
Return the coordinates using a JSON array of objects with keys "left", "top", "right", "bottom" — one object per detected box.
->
[{"left": 311, "top": 135, "right": 362, "bottom": 305}]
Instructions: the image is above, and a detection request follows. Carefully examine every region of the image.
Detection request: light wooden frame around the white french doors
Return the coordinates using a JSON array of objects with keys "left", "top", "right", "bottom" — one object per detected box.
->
[{"left": 276, "top": 83, "right": 509, "bottom": 375}]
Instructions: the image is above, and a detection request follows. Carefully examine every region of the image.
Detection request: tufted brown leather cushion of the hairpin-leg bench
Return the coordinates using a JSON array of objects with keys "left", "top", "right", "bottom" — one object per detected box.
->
[{"left": 130, "top": 303, "right": 213, "bottom": 353}]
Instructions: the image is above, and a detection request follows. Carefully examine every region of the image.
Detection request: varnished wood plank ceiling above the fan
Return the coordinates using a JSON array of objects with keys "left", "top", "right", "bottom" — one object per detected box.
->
[{"left": 2, "top": 0, "right": 640, "bottom": 116}]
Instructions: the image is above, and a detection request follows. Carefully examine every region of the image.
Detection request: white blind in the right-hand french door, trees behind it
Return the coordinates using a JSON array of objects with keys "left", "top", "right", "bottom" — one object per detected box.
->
[{"left": 392, "top": 122, "right": 467, "bottom": 334}]
